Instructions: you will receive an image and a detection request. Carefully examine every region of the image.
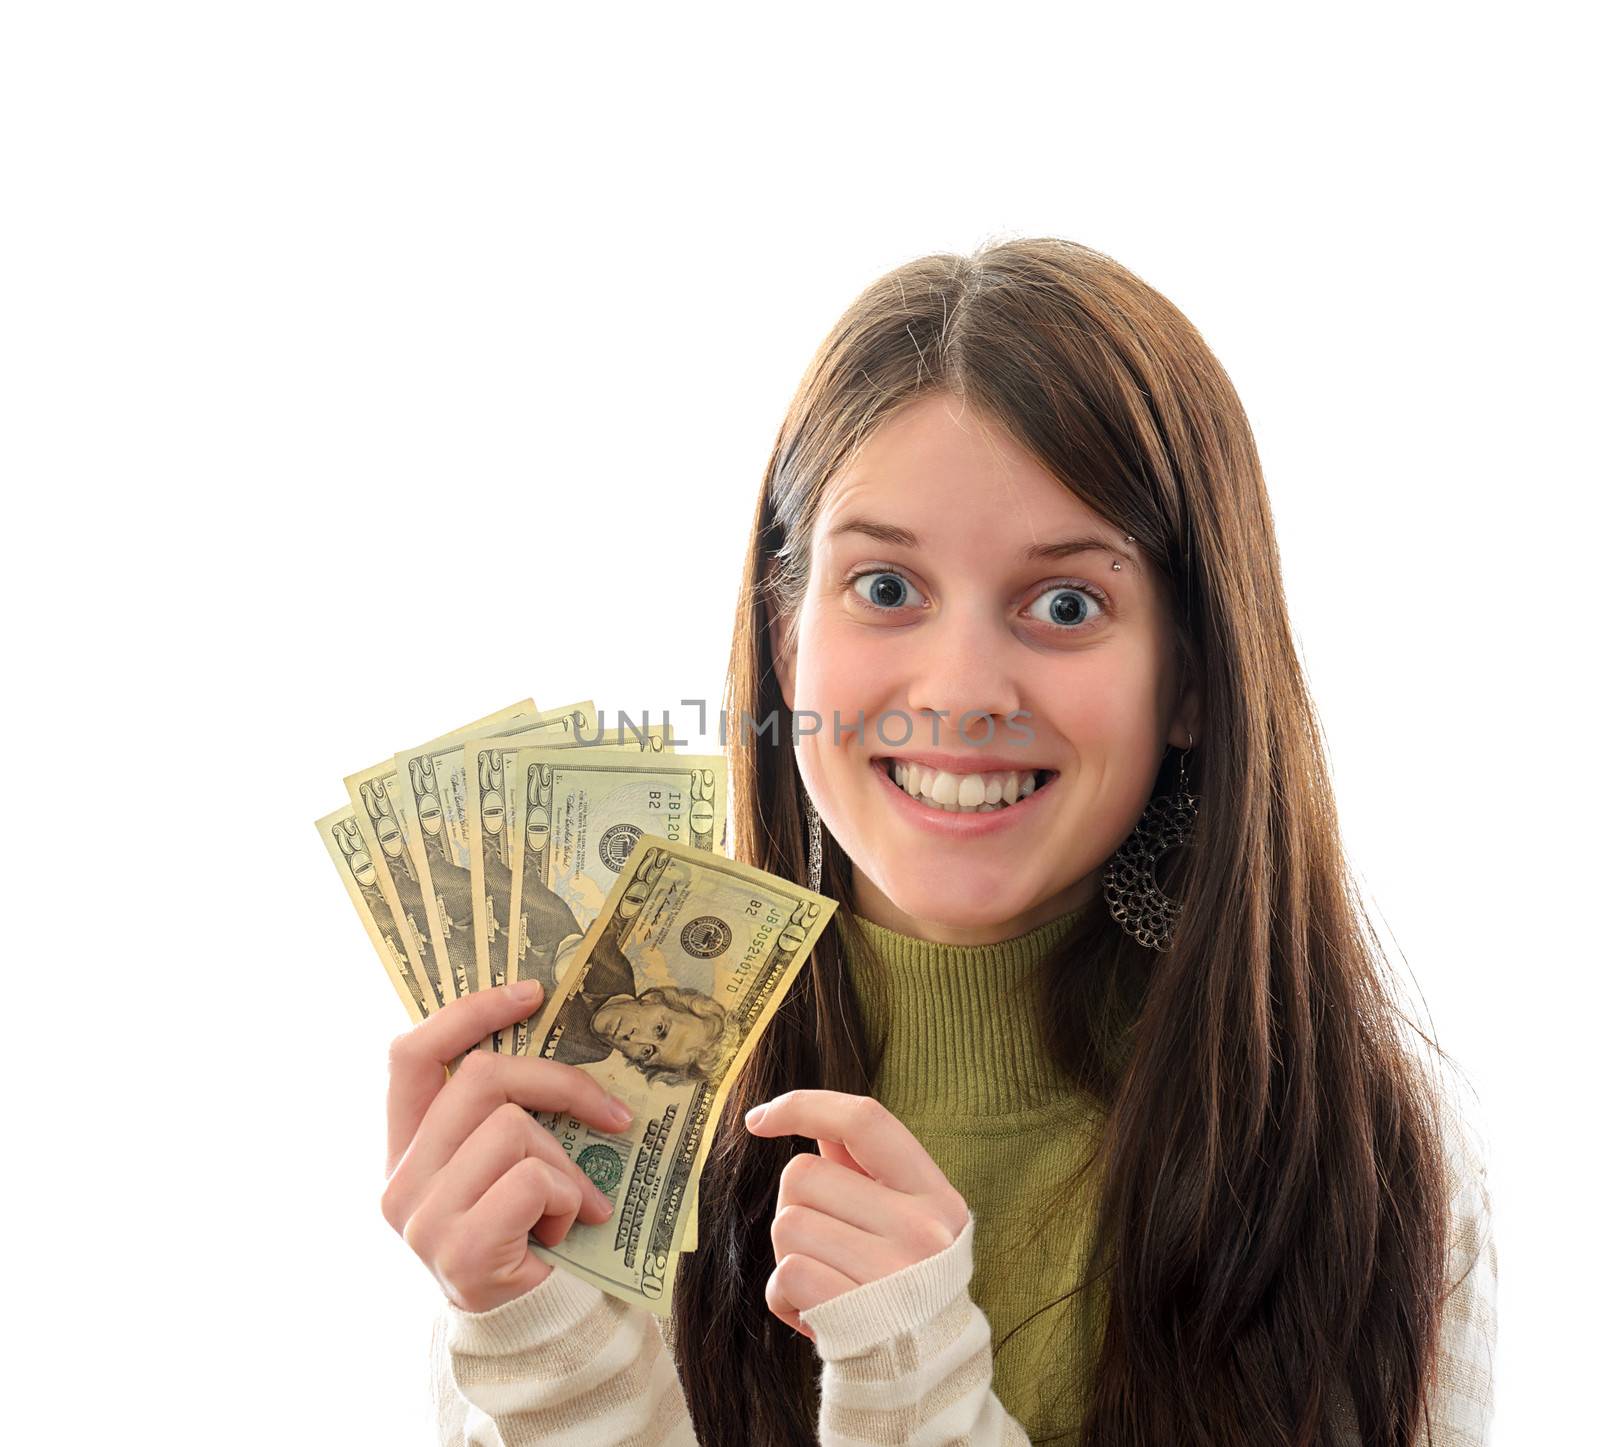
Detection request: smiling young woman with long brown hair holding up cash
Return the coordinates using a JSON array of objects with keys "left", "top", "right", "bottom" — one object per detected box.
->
[{"left": 393, "top": 238, "right": 1494, "bottom": 1447}]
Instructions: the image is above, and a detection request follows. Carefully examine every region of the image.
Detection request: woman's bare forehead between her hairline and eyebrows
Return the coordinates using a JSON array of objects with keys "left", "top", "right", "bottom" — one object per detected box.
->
[{"left": 816, "top": 392, "right": 1118, "bottom": 554}]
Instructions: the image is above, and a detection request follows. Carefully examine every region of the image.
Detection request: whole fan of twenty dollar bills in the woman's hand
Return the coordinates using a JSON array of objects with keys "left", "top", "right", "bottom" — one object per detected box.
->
[{"left": 317, "top": 698, "right": 838, "bottom": 1316}]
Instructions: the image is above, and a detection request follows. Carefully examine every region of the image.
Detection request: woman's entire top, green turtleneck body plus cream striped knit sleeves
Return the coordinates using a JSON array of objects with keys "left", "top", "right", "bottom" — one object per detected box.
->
[{"left": 432, "top": 917, "right": 1496, "bottom": 1447}]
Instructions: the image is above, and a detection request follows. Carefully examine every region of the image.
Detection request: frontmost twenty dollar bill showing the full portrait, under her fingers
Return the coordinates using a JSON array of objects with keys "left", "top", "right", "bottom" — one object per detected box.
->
[{"left": 528, "top": 836, "right": 838, "bottom": 1316}]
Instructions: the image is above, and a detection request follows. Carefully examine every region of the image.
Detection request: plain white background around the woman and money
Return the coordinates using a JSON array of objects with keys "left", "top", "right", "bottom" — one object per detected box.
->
[{"left": 0, "top": 3, "right": 1600, "bottom": 1447}]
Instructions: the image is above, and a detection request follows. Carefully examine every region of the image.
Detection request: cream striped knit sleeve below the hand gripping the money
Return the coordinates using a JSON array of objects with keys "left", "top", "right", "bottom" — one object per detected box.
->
[{"left": 432, "top": 1269, "right": 698, "bottom": 1447}]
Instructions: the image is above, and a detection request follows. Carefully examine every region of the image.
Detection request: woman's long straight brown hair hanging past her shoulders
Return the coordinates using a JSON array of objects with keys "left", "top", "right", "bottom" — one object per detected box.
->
[{"left": 669, "top": 238, "right": 1448, "bottom": 1447}]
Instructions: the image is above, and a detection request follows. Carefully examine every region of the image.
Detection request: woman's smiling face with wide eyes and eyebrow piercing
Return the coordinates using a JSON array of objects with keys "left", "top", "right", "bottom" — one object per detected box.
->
[{"left": 774, "top": 392, "right": 1198, "bottom": 944}]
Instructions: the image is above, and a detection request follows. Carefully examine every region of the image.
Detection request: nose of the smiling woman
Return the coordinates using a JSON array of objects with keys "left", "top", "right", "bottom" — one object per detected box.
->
[{"left": 906, "top": 602, "right": 1026, "bottom": 749}]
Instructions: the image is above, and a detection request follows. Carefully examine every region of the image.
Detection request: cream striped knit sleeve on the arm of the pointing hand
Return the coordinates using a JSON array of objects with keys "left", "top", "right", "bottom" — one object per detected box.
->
[{"left": 800, "top": 1210, "right": 1027, "bottom": 1447}]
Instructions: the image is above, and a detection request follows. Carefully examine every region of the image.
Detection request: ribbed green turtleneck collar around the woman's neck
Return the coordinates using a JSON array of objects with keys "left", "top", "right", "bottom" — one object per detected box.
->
[{"left": 840, "top": 908, "right": 1083, "bottom": 1122}]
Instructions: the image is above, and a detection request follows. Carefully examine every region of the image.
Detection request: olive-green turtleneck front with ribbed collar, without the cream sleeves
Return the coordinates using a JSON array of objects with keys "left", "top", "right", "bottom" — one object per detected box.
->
[{"left": 840, "top": 911, "right": 1106, "bottom": 1442}]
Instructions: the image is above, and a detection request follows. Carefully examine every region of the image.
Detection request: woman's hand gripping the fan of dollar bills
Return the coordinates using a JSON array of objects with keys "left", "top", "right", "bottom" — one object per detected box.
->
[{"left": 382, "top": 981, "right": 629, "bottom": 1313}]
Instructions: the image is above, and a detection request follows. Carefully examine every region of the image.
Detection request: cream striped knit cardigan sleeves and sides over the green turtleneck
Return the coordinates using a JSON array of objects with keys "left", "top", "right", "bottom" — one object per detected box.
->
[{"left": 432, "top": 1088, "right": 1498, "bottom": 1447}]
